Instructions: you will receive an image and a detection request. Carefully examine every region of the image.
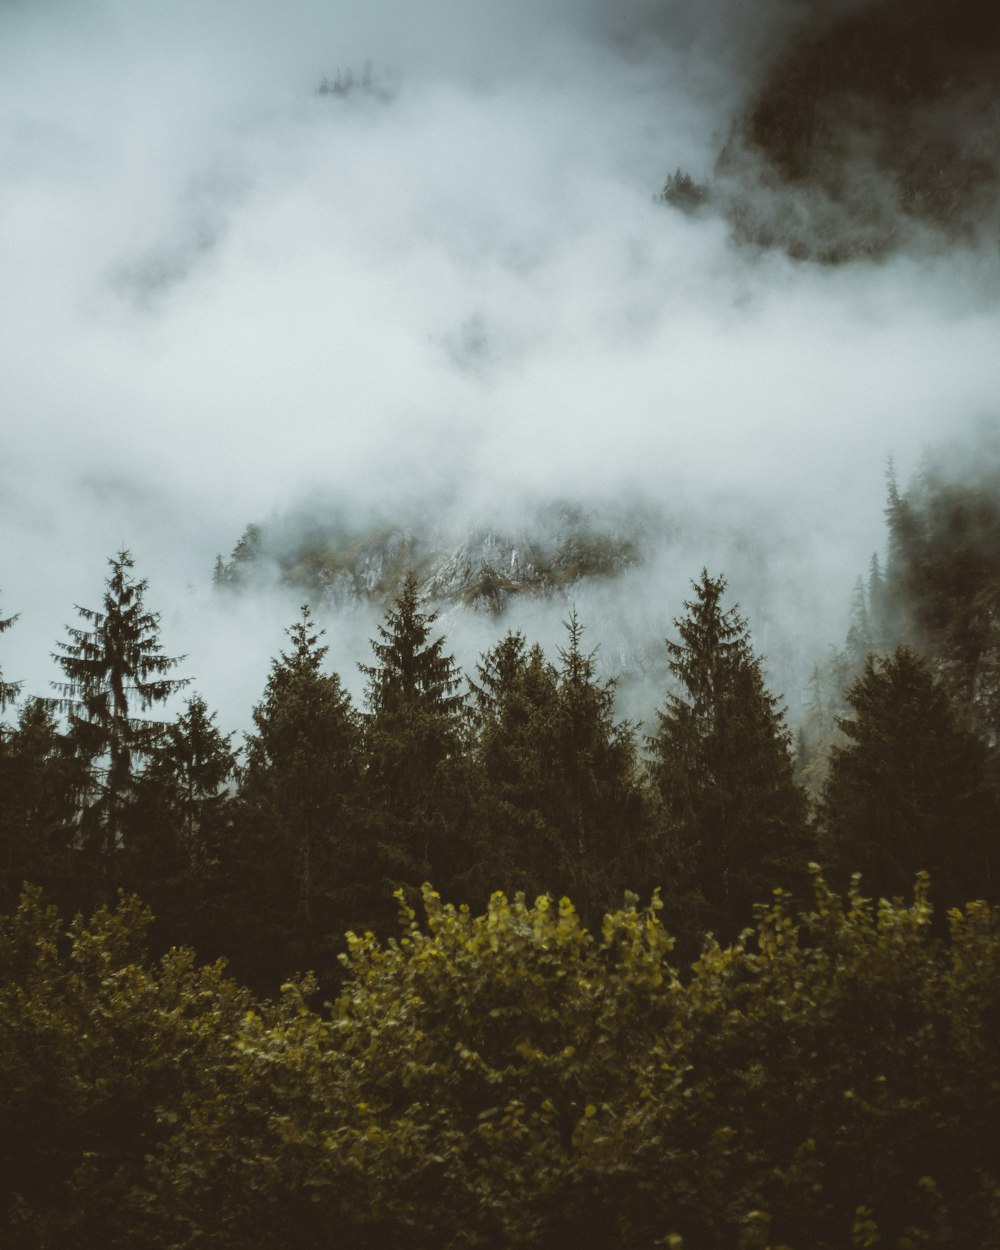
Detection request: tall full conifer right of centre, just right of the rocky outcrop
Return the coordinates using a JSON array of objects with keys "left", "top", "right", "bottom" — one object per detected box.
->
[{"left": 648, "top": 570, "right": 808, "bottom": 934}]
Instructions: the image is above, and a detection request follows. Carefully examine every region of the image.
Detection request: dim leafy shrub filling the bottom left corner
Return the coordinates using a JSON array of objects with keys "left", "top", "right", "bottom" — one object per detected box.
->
[{"left": 0, "top": 890, "right": 254, "bottom": 1250}]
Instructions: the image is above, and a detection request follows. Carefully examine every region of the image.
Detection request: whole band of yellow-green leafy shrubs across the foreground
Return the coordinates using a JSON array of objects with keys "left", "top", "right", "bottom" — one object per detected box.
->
[{"left": 0, "top": 870, "right": 1000, "bottom": 1250}]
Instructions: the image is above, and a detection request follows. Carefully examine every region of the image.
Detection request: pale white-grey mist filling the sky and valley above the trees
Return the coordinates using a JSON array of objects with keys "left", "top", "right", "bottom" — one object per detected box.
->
[{"left": 0, "top": 0, "right": 1000, "bottom": 729}]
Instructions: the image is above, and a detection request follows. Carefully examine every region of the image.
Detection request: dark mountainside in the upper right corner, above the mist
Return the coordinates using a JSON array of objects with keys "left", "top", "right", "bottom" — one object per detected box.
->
[{"left": 664, "top": 0, "right": 1000, "bottom": 263}]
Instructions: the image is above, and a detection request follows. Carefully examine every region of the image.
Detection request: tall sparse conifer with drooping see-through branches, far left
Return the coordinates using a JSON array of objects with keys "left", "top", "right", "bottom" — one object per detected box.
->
[{"left": 51, "top": 550, "right": 188, "bottom": 895}]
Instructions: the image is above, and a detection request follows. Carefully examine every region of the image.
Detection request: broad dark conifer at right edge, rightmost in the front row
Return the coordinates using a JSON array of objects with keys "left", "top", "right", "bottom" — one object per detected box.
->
[{"left": 820, "top": 648, "right": 999, "bottom": 904}]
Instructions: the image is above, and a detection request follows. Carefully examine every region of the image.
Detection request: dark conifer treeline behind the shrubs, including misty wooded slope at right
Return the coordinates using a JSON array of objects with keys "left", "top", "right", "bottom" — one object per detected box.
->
[{"left": 0, "top": 476, "right": 1000, "bottom": 991}]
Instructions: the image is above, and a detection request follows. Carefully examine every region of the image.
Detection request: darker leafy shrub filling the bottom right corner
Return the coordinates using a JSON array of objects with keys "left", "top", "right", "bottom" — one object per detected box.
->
[{"left": 633, "top": 868, "right": 1000, "bottom": 1250}]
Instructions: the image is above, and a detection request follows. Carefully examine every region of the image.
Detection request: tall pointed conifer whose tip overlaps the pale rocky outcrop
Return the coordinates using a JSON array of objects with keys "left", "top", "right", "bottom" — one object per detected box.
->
[{"left": 359, "top": 573, "right": 465, "bottom": 886}]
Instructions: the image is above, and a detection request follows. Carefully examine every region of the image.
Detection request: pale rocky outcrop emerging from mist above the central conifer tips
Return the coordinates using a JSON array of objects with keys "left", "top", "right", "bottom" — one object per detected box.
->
[{"left": 215, "top": 505, "right": 650, "bottom": 616}]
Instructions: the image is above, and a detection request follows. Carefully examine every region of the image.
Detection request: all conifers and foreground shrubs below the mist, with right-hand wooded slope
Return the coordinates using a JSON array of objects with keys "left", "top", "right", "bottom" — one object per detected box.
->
[{"left": 0, "top": 443, "right": 1000, "bottom": 1250}]
